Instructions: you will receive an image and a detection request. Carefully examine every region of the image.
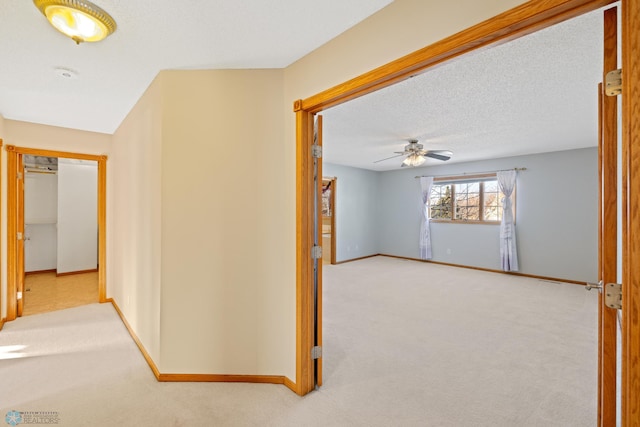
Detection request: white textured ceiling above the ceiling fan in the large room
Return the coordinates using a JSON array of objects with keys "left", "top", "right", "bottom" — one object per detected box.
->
[{"left": 322, "top": 7, "right": 602, "bottom": 171}]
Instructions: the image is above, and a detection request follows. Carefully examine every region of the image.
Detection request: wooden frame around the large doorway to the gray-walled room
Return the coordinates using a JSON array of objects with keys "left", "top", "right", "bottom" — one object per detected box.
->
[{"left": 293, "top": 0, "right": 640, "bottom": 426}]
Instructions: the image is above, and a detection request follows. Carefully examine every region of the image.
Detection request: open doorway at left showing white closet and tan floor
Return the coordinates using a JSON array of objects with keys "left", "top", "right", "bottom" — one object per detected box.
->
[{"left": 22, "top": 155, "right": 99, "bottom": 316}]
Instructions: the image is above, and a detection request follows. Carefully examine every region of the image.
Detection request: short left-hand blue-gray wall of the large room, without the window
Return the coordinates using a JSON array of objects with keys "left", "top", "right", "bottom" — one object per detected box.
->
[{"left": 322, "top": 163, "right": 380, "bottom": 262}]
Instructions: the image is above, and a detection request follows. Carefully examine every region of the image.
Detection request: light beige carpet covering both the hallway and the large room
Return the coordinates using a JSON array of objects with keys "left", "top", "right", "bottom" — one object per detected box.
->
[{"left": 0, "top": 257, "right": 597, "bottom": 427}]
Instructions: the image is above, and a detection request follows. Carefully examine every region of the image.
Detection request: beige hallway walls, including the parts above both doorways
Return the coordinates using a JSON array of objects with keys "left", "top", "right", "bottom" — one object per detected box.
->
[{"left": 0, "top": 0, "right": 523, "bottom": 380}]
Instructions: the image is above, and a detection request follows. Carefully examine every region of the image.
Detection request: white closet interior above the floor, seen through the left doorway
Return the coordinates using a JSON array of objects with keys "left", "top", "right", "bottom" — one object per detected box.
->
[{"left": 24, "top": 156, "right": 98, "bottom": 274}]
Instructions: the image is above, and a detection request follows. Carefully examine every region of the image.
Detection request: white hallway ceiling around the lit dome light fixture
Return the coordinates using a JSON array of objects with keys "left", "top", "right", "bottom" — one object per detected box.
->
[{"left": 0, "top": 0, "right": 392, "bottom": 133}]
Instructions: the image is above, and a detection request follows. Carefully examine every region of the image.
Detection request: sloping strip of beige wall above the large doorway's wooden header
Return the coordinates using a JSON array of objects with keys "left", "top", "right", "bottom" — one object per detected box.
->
[{"left": 285, "top": 0, "right": 525, "bottom": 103}]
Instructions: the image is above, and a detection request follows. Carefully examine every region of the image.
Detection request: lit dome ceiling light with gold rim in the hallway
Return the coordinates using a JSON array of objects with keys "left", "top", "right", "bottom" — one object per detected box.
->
[{"left": 33, "top": 0, "right": 117, "bottom": 44}]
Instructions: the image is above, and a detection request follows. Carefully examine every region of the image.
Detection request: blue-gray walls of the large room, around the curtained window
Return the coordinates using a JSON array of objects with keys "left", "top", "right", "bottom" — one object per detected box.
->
[{"left": 324, "top": 148, "right": 598, "bottom": 281}]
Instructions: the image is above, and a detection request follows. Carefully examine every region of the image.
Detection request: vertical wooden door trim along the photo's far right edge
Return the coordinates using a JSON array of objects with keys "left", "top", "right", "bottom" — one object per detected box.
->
[{"left": 622, "top": 0, "right": 640, "bottom": 426}]
